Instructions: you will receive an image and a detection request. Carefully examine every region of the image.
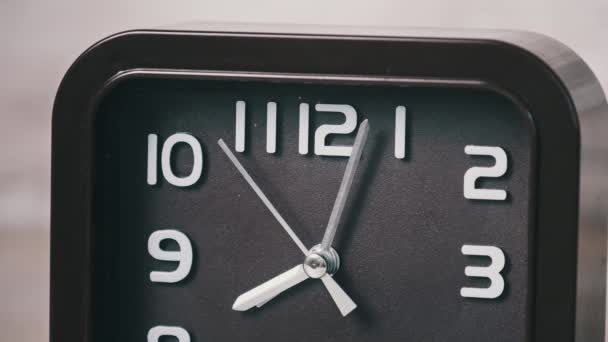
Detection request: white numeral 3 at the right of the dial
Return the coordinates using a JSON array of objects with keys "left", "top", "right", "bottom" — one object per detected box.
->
[{"left": 460, "top": 245, "right": 505, "bottom": 299}]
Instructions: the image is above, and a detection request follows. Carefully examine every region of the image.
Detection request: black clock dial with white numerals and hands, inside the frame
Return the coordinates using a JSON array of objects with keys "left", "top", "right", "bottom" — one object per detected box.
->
[{"left": 92, "top": 78, "right": 535, "bottom": 342}]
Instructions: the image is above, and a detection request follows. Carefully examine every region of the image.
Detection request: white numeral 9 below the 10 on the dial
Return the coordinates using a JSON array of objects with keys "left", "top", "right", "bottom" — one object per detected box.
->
[{"left": 148, "top": 229, "right": 192, "bottom": 283}]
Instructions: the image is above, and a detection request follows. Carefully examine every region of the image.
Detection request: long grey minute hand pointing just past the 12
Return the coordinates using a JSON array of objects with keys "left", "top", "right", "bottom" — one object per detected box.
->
[{"left": 321, "top": 119, "right": 369, "bottom": 251}]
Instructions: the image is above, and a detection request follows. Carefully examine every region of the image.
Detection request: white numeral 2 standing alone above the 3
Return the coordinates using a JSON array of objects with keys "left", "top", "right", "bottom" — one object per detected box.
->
[{"left": 464, "top": 145, "right": 507, "bottom": 201}]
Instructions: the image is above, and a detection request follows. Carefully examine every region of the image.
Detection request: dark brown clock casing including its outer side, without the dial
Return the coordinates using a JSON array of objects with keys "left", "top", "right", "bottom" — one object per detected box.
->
[{"left": 50, "top": 26, "right": 608, "bottom": 342}]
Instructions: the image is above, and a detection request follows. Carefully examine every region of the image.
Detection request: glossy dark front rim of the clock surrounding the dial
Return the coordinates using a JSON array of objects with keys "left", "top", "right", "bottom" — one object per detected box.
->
[{"left": 50, "top": 31, "right": 588, "bottom": 342}]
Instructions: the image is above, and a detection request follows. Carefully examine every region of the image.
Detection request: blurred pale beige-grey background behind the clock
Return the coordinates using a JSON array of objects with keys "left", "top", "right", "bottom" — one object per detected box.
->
[{"left": 0, "top": 0, "right": 608, "bottom": 342}]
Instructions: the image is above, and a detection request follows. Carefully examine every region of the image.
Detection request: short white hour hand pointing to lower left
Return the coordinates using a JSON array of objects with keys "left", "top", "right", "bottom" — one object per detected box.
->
[{"left": 232, "top": 265, "right": 309, "bottom": 311}]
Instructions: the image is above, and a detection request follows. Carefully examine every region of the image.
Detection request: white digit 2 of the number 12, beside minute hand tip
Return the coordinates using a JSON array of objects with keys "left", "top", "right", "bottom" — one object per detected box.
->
[{"left": 315, "top": 104, "right": 357, "bottom": 157}]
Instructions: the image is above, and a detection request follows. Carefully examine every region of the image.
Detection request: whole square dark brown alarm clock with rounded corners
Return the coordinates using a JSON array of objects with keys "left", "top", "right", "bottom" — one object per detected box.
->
[{"left": 50, "top": 26, "right": 608, "bottom": 342}]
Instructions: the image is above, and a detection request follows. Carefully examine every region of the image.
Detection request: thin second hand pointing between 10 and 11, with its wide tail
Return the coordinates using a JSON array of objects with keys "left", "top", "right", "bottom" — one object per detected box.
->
[{"left": 217, "top": 139, "right": 357, "bottom": 316}]
